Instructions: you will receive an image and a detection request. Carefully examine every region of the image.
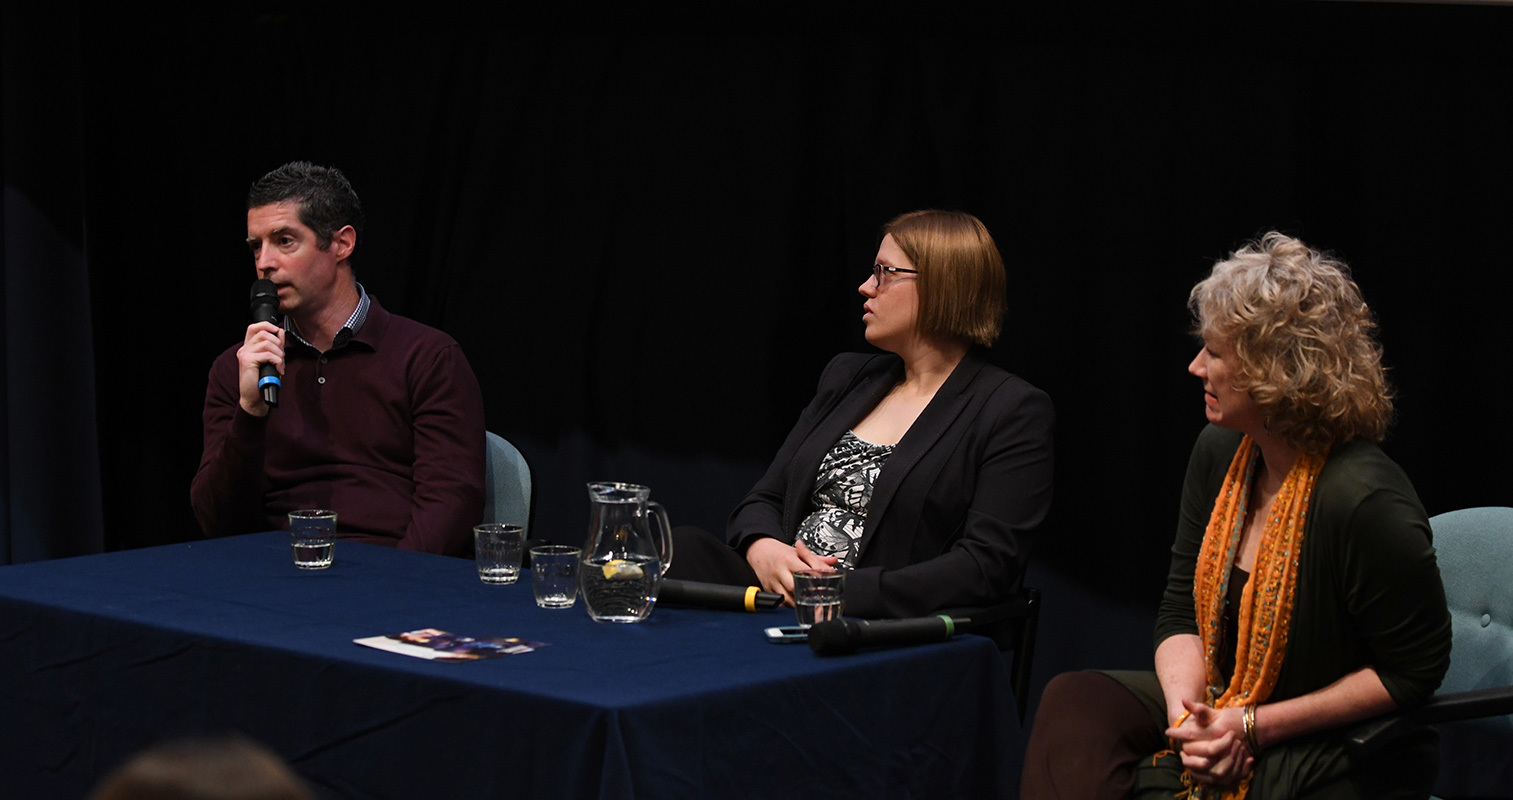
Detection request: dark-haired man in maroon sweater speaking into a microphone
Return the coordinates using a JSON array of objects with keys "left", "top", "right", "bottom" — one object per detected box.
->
[{"left": 191, "top": 162, "right": 484, "bottom": 555}]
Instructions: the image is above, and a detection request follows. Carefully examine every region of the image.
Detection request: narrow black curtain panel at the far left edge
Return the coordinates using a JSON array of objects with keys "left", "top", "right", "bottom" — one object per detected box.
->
[{"left": 0, "top": 5, "right": 104, "bottom": 564}]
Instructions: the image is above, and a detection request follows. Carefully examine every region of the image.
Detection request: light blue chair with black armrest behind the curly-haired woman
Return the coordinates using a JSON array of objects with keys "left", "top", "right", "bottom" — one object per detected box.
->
[{"left": 1347, "top": 508, "right": 1513, "bottom": 797}]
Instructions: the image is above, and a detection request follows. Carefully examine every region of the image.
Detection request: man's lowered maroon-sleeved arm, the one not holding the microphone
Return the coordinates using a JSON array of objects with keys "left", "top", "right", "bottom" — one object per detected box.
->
[{"left": 398, "top": 343, "right": 486, "bottom": 555}]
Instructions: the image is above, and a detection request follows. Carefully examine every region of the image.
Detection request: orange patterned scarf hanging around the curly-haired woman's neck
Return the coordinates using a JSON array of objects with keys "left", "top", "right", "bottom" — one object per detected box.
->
[{"left": 1183, "top": 436, "right": 1327, "bottom": 800}]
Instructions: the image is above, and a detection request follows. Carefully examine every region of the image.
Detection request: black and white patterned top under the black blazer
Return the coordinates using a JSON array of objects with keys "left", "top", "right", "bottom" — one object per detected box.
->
[{"left": 799, "top": 431, "right": 894, "bottom": 569}]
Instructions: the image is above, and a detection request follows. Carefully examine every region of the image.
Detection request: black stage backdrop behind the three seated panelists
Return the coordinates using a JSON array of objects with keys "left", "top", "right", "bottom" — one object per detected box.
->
[{"left": 0, "top": 3, "right": 1513, "bottom": 710}]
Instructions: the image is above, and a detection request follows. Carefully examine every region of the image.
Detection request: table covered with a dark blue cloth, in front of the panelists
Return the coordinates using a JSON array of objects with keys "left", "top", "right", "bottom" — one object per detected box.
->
[{"left": 0, "top": 532, "right": 1023, "bottom": 798}]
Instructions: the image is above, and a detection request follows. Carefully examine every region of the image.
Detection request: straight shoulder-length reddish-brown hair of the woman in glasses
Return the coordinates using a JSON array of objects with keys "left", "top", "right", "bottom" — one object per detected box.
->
[{"left": 882, "top": 210, "right": 1005, "bottom": 346}]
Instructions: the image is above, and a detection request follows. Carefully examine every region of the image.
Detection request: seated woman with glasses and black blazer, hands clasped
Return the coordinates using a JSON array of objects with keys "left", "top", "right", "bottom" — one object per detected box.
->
[{"left": 670, "top": 210, "right": 1053, "bottom": 619}]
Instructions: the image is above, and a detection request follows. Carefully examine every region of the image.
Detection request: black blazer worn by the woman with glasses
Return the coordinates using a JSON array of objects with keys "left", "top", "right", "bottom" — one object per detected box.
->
[{"left": 726, "top": 351, "right": 1055, "bottom": 619}]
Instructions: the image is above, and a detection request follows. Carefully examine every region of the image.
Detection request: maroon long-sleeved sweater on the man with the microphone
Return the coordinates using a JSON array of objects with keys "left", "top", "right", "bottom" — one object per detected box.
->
[{"left": 189, "top": 299, "right": 484, "bottom": 555}]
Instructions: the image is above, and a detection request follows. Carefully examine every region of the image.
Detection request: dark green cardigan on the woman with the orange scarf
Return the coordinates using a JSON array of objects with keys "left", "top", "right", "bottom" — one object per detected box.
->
[{"left": 1156, "top": 425, "right": 1449, "bottom": 708}]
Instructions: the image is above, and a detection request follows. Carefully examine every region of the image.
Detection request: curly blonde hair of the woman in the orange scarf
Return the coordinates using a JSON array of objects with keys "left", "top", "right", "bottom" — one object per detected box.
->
[{"left": 1188, "top": 231, "right": 1392, "bottom": 454}]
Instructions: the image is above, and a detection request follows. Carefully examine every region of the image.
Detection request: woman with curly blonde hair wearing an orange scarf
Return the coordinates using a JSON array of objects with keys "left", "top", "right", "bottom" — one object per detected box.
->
[{"left": 1023, "top": 233, "right": 1449, "bottom": 800}]
